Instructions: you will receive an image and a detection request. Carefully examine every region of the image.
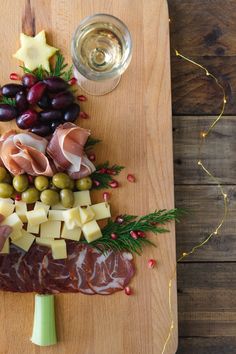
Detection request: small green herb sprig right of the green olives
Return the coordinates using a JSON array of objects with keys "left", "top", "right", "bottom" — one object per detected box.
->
[{"left": 90, "top": 161, "right": 124, "bottom": 189}]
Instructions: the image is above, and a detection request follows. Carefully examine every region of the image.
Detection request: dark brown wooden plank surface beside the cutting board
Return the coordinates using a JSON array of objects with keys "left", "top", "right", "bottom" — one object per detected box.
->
[{"left": 168, "top": 0, "right": 236, "bottom": 354}]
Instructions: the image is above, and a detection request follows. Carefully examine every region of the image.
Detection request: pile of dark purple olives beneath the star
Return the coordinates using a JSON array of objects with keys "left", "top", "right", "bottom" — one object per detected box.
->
[{"left": 0, "top": 74, "right": 80, "bottom": 136}]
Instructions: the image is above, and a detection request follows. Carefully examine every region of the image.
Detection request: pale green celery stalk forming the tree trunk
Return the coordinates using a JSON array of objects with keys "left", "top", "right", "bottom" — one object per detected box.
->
[{"left": 31, "top": 294, "right": 57, "bottom": 346}]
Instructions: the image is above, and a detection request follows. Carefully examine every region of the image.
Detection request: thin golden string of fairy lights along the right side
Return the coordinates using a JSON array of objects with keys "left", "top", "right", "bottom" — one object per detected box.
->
[{"left": 161, "top": 50, "right": 229, "bottom": 354}]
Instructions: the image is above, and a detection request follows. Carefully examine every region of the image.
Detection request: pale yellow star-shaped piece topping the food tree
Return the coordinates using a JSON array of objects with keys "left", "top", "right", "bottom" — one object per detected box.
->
[{"left": 13, "top": 31, "right": 58, "bottom": 71}]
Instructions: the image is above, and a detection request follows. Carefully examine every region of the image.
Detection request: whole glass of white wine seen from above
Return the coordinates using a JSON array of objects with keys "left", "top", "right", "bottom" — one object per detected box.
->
[{"left": 71, "top": 14, "right": 132, "bottom": 96}]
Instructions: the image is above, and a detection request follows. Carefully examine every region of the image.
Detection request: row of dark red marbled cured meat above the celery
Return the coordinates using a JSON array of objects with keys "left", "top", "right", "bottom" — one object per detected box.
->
[{"left": 0, "top": 241, "right": 135, "bottom": 295}]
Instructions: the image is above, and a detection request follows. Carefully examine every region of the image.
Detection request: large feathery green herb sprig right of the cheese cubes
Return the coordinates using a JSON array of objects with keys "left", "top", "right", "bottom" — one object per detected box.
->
[{"left": 90, "top": 209, "right": 184, "bottom": 255}]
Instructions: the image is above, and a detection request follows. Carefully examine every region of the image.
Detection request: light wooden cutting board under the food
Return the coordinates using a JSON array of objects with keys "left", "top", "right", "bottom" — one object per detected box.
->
[{"left": 0, "top": 0, "right": 177, "bottom": 354}]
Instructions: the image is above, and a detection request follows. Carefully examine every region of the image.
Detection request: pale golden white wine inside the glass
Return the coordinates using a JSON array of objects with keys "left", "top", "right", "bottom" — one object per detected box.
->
[{"left": 76, "top": 22, "right": 125, "bottom": 73}]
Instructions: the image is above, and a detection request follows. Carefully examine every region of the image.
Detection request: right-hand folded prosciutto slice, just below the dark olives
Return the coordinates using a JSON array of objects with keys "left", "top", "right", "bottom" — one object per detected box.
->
[{"left": 47, "top": 123, "right": 95, "bottom": 179}]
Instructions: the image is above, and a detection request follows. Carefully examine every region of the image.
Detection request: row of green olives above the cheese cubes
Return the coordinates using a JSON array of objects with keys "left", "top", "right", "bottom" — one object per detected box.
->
[{"left": 0, "top": 167, "right": 92, "bottom": 208}]
